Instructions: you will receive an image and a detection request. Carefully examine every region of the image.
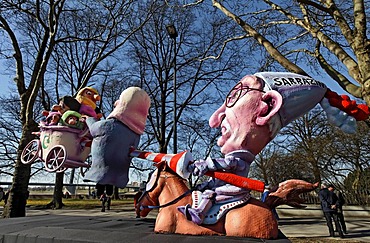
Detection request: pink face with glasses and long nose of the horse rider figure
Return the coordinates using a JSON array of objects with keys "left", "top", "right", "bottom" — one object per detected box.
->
[{"left": 209, "top": 76, "right": 264, "bottom": 154}]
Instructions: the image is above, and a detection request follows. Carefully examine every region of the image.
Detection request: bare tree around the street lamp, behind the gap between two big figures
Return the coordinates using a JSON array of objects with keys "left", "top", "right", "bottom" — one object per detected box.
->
[{"left": 127, "top": 0, "right": 244, "bottom": 160}]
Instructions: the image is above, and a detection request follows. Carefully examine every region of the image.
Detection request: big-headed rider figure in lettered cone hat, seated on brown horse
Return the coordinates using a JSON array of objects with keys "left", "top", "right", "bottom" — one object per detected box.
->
[{"left": 178, "top": 72, "right": 370, "bottom": 224}]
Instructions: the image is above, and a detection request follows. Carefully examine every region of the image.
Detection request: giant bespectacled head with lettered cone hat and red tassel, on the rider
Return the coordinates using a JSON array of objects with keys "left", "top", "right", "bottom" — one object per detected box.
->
[{"left": 209, "top": 72, "right": 369, "bottom": 155}]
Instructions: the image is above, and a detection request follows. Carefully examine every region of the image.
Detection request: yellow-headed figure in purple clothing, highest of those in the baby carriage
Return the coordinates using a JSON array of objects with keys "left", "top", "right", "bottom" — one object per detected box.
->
[{"left": 76, "top": 87, "right": 103, "bottom": 119}]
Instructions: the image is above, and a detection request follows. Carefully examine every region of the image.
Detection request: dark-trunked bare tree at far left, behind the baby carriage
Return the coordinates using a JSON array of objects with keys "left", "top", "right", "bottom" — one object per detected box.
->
[{"left": 0, "top": 0, "right": 154, "bottom": 217}]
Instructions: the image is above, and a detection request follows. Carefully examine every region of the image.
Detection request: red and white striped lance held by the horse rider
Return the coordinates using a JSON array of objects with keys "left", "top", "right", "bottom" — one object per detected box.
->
[{"left": 130, "top": 149, "right": 265, "bottom": 192}]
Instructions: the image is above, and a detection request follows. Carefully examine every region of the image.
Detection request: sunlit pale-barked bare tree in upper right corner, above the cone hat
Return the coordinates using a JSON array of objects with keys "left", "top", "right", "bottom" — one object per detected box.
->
[{"left": 178, "top": 0, "right": 370, "bottom": 106}]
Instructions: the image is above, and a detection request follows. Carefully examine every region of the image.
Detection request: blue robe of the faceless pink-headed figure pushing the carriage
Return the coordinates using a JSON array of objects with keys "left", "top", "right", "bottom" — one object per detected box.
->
[{"left": 84, "top": 117, "right": 140, "bottom": 188}]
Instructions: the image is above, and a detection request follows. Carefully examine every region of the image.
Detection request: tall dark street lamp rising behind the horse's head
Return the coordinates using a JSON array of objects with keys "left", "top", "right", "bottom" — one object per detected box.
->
[{"left": 166, "top": 24, "right": 178, "bottom": 154}]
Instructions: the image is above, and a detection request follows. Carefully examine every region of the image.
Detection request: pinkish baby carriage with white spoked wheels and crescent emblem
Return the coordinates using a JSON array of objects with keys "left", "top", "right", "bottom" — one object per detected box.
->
[{"left": 21, "top": 123, "right": 91, "bottom": 176}]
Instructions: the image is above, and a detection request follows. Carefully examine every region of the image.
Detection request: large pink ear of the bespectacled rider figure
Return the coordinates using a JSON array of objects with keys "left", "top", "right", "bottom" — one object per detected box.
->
[{"left": 256, "top": 90, "right": 283, "bottom": 126}]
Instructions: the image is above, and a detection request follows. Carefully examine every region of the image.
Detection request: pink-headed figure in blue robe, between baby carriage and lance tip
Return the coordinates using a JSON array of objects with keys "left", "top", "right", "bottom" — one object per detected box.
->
[{"left": 84, "top": 87, "right": 150, "bottom": 188}]
